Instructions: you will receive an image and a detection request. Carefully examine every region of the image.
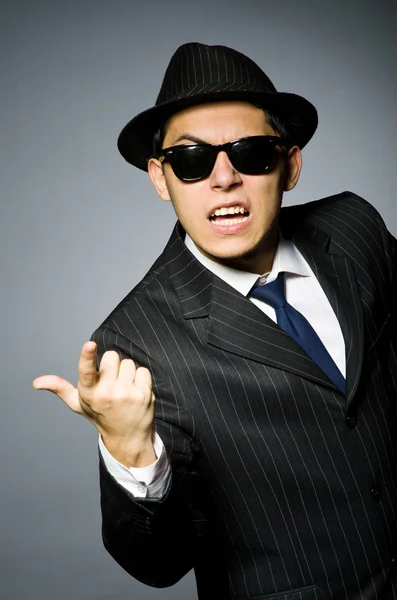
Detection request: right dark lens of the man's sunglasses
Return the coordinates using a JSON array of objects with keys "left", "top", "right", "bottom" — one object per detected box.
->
[{"left": 231, "top": 137, "right": 276, "bottom": 175}]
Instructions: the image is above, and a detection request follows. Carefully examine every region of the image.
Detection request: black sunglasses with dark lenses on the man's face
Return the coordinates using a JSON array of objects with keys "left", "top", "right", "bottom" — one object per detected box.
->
[{"left": 159, "top": 135, "right": 287, "bottom": 181}]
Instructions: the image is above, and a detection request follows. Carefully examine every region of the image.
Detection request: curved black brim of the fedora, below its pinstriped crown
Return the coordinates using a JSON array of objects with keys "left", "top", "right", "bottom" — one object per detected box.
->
[{"left": 117, "top": 91, "right": 318, "bottom": 171}]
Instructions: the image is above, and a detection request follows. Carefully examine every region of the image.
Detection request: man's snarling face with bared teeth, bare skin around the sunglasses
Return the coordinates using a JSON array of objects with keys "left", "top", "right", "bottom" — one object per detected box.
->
[{"left": 149, "top": 101, "right": 301, "bottom": 274}]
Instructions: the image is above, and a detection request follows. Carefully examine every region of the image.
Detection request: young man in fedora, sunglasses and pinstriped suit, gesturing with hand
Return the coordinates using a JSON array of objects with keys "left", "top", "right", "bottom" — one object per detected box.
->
[{"left": 34, "top": 43, "right": 397, "bottom": 600}]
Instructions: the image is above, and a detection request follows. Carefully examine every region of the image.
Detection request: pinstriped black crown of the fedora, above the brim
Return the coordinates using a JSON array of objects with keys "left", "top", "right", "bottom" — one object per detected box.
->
[{"left": 156, "top": 42, "right": 277, "bottom": 106}]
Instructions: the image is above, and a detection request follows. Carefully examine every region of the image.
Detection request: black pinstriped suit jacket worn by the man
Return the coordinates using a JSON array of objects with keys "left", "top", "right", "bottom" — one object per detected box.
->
[{"left": 93, "top": 192, "right": 397, "bottom": 600}]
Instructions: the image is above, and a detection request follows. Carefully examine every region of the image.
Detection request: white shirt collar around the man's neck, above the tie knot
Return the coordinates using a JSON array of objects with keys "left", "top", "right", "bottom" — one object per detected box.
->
[{"left": 185, "top": 233, "right": 310, "bottom": 296}]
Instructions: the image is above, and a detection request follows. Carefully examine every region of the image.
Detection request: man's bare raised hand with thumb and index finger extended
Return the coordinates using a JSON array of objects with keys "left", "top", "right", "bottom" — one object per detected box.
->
[{"left": 33, "top": 342, "right": 156, "bottom": 467}]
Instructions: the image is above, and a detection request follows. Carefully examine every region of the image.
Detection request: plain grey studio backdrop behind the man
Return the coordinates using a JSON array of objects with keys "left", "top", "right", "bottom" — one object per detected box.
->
[{"left": 0, "top": 0, "right": 397, "bottom": 600}]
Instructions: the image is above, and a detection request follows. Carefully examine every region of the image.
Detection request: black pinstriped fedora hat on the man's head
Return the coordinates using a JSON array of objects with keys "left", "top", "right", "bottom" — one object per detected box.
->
[{"left": 118, "top": 42, "right": 318, "bottom": 171}]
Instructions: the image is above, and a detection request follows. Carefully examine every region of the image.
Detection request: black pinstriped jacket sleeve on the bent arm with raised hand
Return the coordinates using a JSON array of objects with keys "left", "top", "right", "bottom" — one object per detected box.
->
[{"left": 92, "top": 326, "right": 215, "bottom": 587}]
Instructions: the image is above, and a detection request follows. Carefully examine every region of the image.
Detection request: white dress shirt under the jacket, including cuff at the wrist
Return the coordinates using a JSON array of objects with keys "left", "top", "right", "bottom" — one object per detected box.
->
[{"left": 99, "top": 235, "right": 346, "bottom": 498}]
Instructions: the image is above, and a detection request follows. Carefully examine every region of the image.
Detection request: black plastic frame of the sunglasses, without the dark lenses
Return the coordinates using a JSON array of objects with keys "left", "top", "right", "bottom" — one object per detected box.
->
[{"left": 159, "top": 135, "right": 288, "bottom": 182}]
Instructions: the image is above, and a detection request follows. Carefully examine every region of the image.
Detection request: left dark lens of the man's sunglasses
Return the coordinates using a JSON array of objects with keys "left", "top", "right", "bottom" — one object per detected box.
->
[{"left": 172, "top": 145, "right": 214, "bottom": 181}]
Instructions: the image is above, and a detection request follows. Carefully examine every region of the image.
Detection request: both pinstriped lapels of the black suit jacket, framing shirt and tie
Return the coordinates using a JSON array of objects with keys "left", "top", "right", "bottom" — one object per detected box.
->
[{"left": 165, "top": 219, "right": 363, "bottom": 400}]
